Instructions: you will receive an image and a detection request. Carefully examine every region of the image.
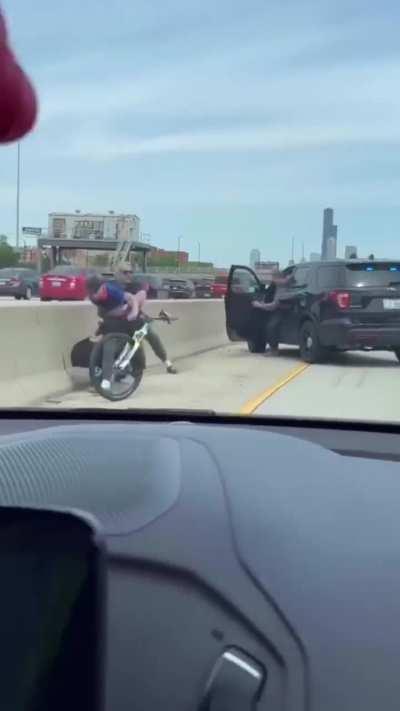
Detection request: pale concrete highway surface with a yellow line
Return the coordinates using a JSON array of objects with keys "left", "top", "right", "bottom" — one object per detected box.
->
[{"left": 41, "top": 344, "right": 400, "bottom": 422}]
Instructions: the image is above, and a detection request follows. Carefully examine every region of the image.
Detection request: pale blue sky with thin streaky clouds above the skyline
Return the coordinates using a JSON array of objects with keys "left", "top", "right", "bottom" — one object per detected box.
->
[{"left": 0, "top": 0, "right": 400, "bottom": 266}]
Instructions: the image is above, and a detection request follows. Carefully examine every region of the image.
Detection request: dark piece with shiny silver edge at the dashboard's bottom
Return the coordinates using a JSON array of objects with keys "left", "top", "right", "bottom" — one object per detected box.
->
[{"left": 199, "top": 647, "right": 266, "bottom": 711}]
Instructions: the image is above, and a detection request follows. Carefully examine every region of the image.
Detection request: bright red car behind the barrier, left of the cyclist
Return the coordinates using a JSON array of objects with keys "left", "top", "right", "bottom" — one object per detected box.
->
[{"left": 39, "top": 265, "right": 97, "bottom": 301}]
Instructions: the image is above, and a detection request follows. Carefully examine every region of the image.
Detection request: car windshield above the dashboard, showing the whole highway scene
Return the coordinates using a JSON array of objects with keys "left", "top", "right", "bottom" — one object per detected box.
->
[{"left": 0, "top": 0, "right": 400, "bottom": 422}]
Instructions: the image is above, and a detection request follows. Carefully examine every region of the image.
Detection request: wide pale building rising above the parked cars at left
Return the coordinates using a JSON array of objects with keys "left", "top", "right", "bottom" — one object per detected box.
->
[{"left": 48, "top": 210, "right": 141, "bottom": 242}]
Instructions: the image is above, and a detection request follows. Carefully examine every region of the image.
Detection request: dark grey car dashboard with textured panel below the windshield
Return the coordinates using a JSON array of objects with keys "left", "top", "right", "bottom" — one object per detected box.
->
[{"left": 0, "top": 412, "right": 400, "bottom": 711}]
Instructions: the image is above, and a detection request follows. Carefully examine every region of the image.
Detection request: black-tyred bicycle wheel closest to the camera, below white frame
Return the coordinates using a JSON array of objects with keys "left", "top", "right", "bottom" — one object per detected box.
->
[{"left": 89, "top": 333, "right": 146, "bottom": 402}]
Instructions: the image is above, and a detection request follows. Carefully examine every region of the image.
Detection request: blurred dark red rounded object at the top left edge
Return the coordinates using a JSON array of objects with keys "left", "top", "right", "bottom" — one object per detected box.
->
[{"left": 0, "top": 10, "right": 37, "bottom": 143}]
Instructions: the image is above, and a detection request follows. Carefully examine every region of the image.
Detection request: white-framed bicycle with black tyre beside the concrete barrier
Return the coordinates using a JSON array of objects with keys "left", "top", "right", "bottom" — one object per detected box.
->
[{"left": 89, "top": 309, "right": 177, "bottom": 402}]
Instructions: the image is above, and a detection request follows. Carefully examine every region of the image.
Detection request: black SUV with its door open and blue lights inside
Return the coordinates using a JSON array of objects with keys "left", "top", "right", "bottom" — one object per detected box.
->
[{"left": 225, "top": 260, "right": 400, "bottom": 363}]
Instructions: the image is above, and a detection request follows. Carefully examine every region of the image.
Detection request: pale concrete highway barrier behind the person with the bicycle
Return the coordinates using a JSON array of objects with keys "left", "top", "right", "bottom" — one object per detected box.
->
[{"left": 0, "top": 300, "right": 227, "bottom": 407}]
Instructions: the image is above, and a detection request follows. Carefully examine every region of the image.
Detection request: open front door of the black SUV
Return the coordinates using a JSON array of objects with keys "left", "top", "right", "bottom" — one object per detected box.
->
[{"left": 225, "top": 264, "right": 265, "bottom": 341}]
